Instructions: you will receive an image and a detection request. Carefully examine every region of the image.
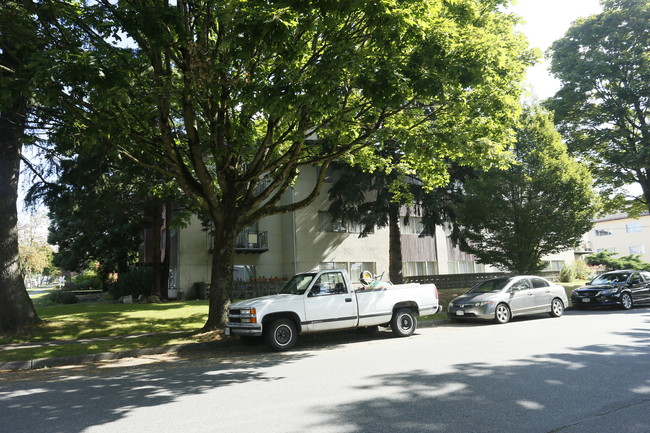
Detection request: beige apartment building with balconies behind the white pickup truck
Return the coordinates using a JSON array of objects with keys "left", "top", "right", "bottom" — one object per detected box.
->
[{"left": 165, "top": 168, "right": 574, "bottom": 292}]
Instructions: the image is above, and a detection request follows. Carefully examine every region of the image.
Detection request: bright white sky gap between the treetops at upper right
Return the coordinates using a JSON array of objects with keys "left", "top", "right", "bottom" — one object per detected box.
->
[{"left": 509, "top": 0, "right": 602, "bottom": 100}]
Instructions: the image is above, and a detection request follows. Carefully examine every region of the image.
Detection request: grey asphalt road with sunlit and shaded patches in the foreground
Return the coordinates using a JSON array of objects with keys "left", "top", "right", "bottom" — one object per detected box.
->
[{"left": 0, "top": 308, "right": 650, "bottom": 433}]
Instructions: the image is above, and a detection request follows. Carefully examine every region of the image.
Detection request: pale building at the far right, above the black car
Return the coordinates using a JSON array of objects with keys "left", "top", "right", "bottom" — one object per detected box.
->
[{"left": 587, "top": 213, "right": 650, "bottom": 262}]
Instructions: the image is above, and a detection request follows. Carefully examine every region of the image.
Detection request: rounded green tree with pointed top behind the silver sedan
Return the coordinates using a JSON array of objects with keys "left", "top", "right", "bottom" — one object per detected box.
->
[{"left": 456, "top": 107, "right": 597, "bottom": 273}]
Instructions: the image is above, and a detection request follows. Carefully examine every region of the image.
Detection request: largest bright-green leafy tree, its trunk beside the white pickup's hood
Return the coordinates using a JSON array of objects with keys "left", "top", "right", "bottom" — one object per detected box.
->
[{"left": 53, "top": 0, "right": 531, "bottom": 328}]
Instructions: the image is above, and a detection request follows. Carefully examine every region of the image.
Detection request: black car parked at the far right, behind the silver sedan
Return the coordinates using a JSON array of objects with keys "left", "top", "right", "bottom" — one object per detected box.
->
[{"left": 571, "top": 270, "right": 650, "bottom": 310}]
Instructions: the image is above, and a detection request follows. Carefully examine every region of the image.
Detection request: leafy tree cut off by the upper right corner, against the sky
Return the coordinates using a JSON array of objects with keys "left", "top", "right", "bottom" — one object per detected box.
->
[{"left": 549, "top": 0, "right": 650, "bottom": 213}]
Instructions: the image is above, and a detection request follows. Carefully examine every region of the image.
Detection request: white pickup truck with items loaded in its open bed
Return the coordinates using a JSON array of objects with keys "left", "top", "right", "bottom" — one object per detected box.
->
[{"left": 226, "top": 270, "right": 440, "bottom": 351}]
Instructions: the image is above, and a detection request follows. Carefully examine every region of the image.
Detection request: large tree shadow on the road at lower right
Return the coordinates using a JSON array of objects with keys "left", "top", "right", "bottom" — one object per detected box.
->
[{"left": 296, "top": 310, "right": 650, "bottom": 433}]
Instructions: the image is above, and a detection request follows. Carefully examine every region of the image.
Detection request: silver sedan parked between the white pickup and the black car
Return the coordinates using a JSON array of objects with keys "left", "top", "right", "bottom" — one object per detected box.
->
[{"left": 447, "top": 275, "right": 569, "bottom": 323}]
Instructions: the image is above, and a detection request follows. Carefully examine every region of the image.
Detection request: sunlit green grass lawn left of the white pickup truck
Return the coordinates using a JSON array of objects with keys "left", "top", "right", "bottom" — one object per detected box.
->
[{"left": 0, "top": 301, "right": 213, "bottom": 361}]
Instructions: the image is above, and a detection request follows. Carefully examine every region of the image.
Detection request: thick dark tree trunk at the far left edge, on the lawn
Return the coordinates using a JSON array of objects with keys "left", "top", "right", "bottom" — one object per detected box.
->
[{"left": 0, "top": 97, "right": 41, "bottom": 333}]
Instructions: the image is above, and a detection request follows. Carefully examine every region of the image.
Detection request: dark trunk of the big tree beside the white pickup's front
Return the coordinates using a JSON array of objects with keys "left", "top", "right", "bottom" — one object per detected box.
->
[{"left": 203, "top": 224, "right": 238, "bottom": 331}]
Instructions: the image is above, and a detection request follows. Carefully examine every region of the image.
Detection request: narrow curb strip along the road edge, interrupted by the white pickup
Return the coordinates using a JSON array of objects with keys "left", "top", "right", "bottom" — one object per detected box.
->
[{"left": 0, "top": 319, "right": 451, "bottom": 371}]
